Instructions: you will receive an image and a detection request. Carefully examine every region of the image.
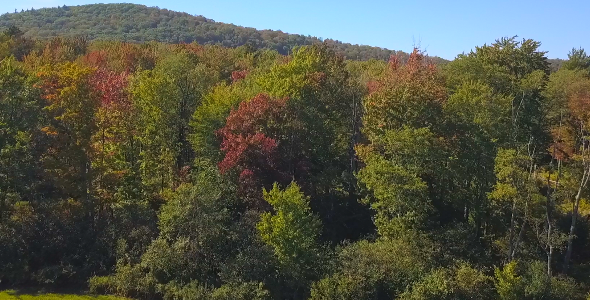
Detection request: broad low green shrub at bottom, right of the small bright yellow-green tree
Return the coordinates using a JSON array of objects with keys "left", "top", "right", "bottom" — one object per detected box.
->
[{"left": 310, "top": 235, "right": 435, "bottom": 300}]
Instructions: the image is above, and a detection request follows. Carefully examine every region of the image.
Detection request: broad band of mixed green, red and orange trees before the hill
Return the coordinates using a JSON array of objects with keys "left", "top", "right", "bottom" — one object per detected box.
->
[{"left": 0, "top": 13, "right": 590, "bottom": 300}]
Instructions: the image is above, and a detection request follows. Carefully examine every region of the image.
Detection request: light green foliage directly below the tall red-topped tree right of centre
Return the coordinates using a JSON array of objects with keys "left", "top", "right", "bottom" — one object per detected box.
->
[{"left": 357, "top": 128, "right": 436, "bottom": 237}]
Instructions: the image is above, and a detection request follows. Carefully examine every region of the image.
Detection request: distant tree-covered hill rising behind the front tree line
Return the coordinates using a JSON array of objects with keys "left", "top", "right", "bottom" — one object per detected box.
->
[{"left": 0, "top": 4, "right": 445, "bottom": 62}]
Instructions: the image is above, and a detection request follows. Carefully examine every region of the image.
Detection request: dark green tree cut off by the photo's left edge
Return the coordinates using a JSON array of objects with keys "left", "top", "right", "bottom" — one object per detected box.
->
[{"left": 0, "top": 58, "right": 43, "bottom": 284}]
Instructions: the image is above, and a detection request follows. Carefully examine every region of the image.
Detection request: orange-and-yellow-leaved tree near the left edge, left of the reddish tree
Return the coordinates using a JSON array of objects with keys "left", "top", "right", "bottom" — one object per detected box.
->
[{"left": 37, "top": 63, "right": 99, "bottom": 207}]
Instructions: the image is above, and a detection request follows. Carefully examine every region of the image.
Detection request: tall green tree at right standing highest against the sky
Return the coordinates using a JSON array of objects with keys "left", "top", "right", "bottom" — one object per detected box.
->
[{"left": 444, "top": 37, "right": 552, "bottom": 270}]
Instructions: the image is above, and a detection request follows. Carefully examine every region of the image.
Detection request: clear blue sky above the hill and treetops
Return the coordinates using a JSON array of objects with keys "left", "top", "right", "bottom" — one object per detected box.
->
[{"left": 0, "top": 0, "right": 590, "bottom": 59}]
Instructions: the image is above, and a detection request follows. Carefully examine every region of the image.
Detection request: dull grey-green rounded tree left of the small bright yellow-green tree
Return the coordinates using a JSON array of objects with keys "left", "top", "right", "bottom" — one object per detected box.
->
[{"left": 141, "top": 174, "right": 234, "bottom": 283}]
